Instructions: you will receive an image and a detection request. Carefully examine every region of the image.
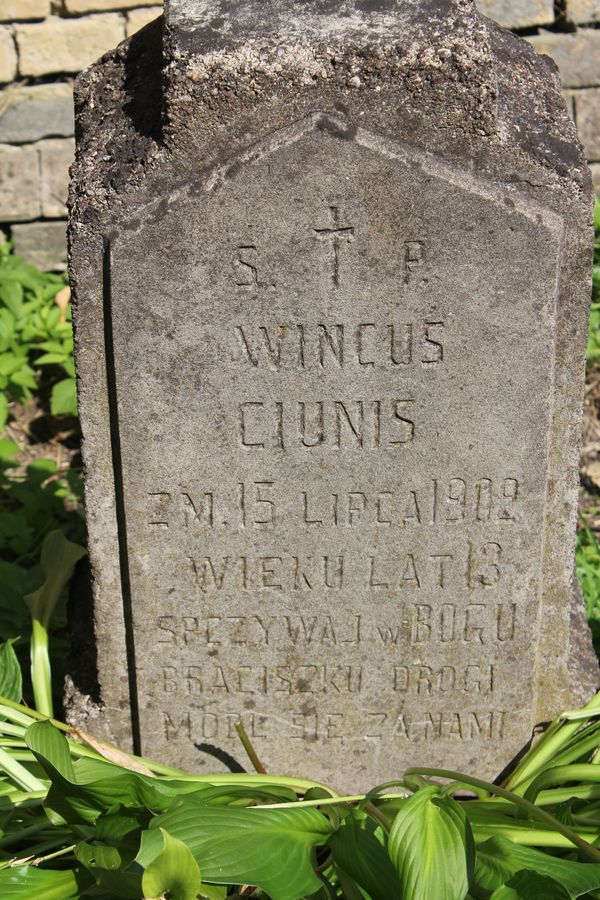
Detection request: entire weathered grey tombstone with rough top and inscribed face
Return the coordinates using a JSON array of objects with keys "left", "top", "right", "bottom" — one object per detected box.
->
[{"left": 70, "top": 0, "right": 595, "bottom": 790}]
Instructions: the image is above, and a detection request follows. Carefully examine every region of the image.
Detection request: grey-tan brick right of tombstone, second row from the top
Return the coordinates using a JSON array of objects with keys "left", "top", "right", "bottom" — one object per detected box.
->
[{"left": 526, "top": 28, "right": 600, "bottom": 88}]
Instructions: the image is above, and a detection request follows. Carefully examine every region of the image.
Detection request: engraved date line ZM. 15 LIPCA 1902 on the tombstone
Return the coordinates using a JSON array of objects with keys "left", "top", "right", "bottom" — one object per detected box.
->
[{"left": 147, "top": 477, "right": 523, "bottom": 533}]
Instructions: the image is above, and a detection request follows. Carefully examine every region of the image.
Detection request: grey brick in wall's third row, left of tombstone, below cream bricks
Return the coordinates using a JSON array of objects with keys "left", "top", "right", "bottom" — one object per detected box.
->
[{"left": 0, "top": 82, "right": 75, "bottom": 144}]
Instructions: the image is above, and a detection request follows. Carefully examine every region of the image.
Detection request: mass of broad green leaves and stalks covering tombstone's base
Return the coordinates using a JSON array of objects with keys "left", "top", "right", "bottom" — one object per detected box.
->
[{"left": 0, "top": 688, "right": 600, "bottom": 900}]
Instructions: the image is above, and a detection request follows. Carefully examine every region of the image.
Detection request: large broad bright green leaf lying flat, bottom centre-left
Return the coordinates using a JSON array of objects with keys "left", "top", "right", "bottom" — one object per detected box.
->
[{"left": 150, "top": 797, "right": 333, "bottom": 900}]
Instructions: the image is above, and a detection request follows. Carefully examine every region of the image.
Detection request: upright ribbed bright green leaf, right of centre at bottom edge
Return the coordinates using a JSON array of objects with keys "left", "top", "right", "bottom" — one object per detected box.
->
[{"left": 388, "top": 786, "right": 474, "bottom": 900}]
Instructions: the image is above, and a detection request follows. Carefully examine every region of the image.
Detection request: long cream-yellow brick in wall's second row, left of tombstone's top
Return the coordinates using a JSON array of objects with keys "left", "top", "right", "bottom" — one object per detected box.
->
[{"left": 15, "top": 13, "right": 125, "bottom": 76}]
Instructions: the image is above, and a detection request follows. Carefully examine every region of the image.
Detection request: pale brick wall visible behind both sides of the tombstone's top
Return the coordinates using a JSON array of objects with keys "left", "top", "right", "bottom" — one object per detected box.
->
[{"left": 0, "top": 0, "right": 600, "bottom": 269}]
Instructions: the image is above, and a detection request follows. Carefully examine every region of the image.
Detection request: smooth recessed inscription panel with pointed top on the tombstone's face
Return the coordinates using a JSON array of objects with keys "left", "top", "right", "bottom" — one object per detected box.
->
[{"left": 111, "top": 125, "right": 556, "bottom": 780}]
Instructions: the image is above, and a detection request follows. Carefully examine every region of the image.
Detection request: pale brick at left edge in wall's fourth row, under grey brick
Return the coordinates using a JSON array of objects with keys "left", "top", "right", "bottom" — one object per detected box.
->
[{"left": 0, "top": 145, "right": 41, "bottom": 222}]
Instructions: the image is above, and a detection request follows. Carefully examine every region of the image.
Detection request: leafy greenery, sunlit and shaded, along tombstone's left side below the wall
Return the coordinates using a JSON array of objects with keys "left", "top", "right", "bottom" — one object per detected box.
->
[{"left": 0, "top": 244, "right": 85, "bottom": 713}]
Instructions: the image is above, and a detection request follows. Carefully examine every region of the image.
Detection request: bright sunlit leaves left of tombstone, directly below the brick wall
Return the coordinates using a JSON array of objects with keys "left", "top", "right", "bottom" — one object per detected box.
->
[{"left": 0, "top": 244, "right": 77, "bottom": 416}]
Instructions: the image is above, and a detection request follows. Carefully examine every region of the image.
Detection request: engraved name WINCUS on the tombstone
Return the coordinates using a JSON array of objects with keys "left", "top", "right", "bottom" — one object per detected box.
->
[{"left": 232, "top": 319, "right": 445, "bottom": 373}]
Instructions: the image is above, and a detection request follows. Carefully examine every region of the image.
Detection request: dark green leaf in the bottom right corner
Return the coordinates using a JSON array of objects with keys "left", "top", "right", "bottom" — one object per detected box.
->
[{"left": 474, "top": 837, "right": 600, "bottom": 897}]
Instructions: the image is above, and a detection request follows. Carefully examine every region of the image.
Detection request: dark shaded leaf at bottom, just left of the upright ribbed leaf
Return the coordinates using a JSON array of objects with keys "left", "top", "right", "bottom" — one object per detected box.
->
[{"left": 328, "top": 811, "right": 402, "bottom": 900}]
